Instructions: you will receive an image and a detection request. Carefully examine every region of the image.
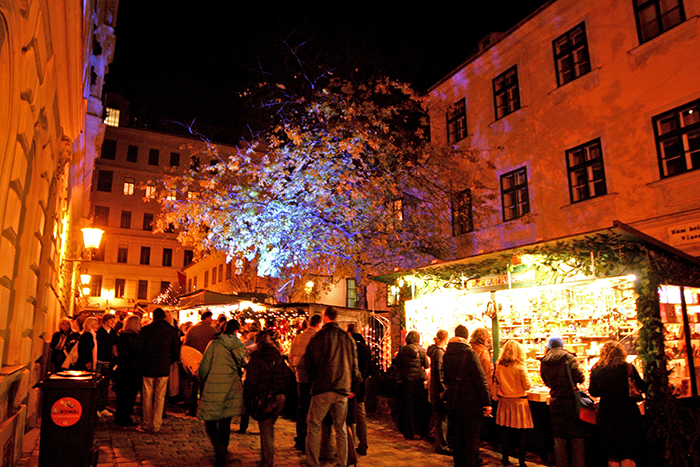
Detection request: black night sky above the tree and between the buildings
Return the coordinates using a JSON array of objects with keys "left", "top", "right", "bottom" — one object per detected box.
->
[{"left": 105, "top": 0, "right": 546, "bottom": 141}]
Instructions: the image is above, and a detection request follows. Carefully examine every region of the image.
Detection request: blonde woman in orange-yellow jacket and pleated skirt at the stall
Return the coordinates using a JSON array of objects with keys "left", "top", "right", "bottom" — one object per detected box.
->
[{"left": 496, "top": 340, "right": 534, "bottom": 467}]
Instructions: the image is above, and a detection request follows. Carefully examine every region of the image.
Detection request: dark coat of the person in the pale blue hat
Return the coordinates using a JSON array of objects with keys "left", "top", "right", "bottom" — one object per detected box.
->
[{"left": 540, "top": 347, "right": 588, "bottom": 439}]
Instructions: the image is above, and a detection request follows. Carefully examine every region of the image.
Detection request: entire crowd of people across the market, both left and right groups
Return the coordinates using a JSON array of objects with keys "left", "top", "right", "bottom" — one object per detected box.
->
[{"left": 50, "top": 307, "right": 645, "bottom": 467}]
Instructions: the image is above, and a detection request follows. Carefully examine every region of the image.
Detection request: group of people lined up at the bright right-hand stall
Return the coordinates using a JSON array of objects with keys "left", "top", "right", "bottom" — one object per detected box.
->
[{"left": 394, "top": 325, "right": 646, "bottom": 467}]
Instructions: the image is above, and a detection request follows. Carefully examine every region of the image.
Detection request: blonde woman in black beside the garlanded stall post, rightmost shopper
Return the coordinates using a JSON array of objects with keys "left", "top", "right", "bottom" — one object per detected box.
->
[{"left": 589, "top": 342, "right": 647, "bottom": 467}]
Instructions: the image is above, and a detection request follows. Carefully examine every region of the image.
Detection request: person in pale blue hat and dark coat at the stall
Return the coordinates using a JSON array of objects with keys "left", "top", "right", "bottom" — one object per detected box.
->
[{"left": 540, "top": 335, "right": 588, "bottom": 467}]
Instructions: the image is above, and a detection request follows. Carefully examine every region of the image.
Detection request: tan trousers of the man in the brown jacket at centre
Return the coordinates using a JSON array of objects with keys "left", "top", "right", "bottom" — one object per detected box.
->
[{"left": 306, "top": 391, "right": 348, "bottom": 467}]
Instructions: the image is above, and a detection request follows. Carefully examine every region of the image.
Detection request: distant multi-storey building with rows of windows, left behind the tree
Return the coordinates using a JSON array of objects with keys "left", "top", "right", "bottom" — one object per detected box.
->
[{"left": 85, "top": 121, "right": 243, "bottom": 310}]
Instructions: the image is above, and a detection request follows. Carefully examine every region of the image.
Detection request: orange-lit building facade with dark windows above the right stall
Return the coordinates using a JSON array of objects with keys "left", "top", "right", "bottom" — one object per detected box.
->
[{"left": 429, "top": 0, "right": 700, "bottom": 256}]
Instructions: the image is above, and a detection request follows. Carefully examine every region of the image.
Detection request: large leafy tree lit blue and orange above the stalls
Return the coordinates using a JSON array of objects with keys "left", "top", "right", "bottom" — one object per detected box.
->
[{"left": 153, "top": 77, "right": 492, "bottom": 304}]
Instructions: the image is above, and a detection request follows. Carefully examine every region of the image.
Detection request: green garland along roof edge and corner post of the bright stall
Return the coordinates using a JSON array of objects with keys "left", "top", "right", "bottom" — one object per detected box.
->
[{"left": 401, "top": 233, "right": 700, "bottom": 466}]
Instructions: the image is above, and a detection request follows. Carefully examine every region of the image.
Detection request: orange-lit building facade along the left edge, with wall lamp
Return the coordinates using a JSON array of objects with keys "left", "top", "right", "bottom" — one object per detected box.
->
[{"left": 0, "top": 0, "right": 119, "bottom": 465}]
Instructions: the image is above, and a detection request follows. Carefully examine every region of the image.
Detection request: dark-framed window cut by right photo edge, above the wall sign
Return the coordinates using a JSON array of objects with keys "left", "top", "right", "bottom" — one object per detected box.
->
[{"left": 652, "top": 100, "right": 700, "bottom": 178}]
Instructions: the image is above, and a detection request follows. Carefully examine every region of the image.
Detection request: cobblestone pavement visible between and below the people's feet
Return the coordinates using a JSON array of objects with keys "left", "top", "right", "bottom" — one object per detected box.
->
[{"left": 17, "top": 405, "right": 542, "bottom": 467}]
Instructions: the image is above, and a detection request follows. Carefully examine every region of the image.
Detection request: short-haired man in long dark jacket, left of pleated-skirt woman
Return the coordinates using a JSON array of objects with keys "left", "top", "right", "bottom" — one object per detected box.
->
[{"left": 442, "top": 324, "right": 491, "bottom": 467}]
